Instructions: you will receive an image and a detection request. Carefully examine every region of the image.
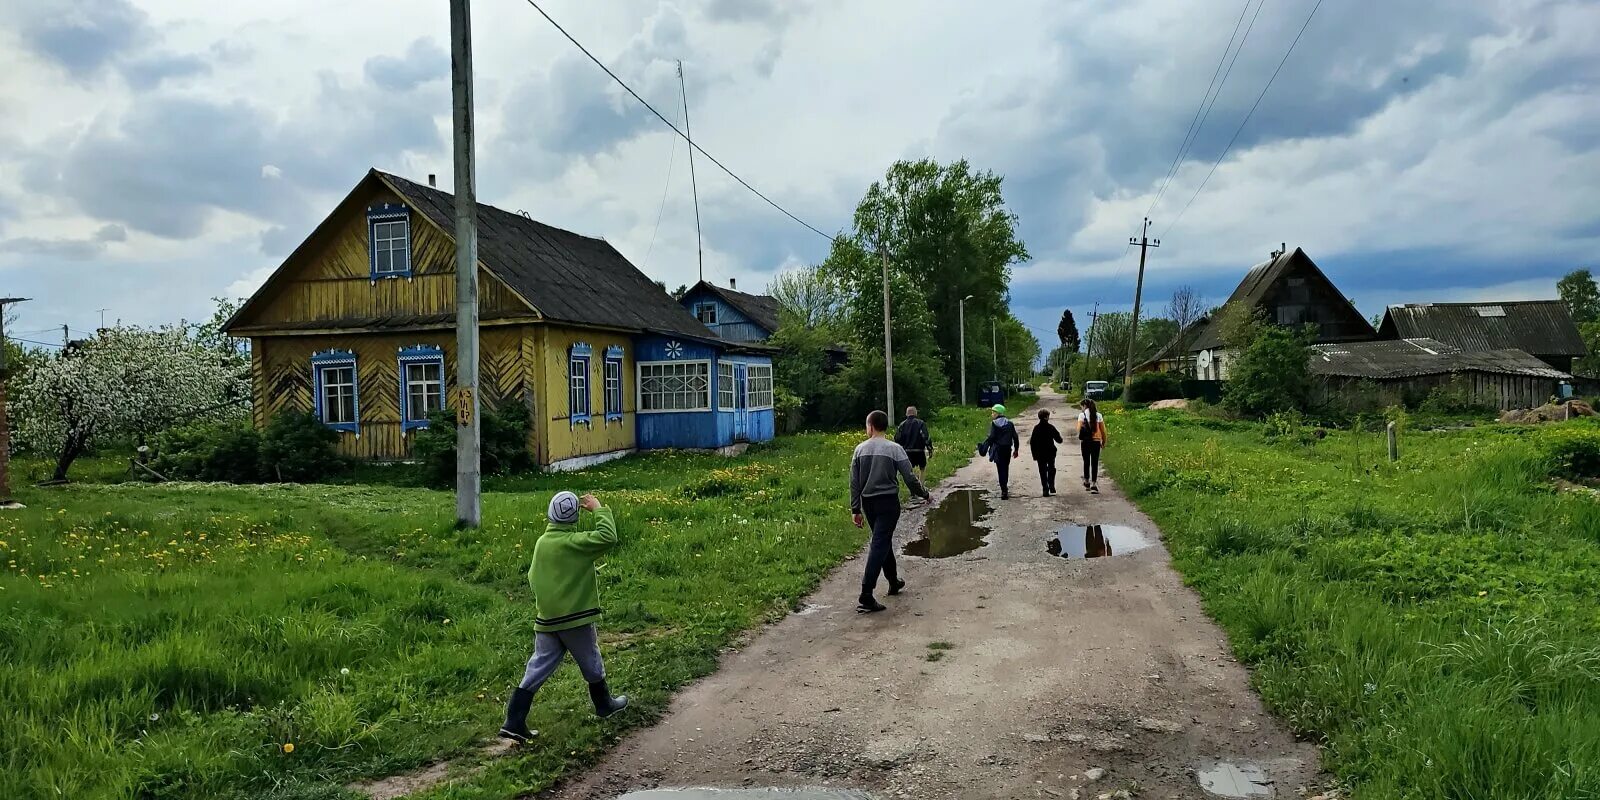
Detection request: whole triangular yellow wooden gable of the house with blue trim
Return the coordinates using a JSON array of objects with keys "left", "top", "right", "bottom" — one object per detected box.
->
[{"left": 227, "top": 173, "right": 538, "bottom": 336}]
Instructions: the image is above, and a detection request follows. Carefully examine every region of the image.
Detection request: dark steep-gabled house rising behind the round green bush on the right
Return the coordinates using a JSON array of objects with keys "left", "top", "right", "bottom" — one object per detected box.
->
[{"left": 1189, "top": 248, "right": 1376, "bottom": 381}]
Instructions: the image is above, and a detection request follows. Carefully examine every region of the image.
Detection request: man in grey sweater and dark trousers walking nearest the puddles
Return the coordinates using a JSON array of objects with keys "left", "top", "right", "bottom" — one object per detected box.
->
[{"left": 850, "top": 411, "right": 928, "bottom": 613}]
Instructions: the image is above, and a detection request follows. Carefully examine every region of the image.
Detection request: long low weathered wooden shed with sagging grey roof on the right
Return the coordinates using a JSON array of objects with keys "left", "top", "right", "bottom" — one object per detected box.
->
[{"left": 1310, "top": 338, "right": 1571, "bottom": 410}]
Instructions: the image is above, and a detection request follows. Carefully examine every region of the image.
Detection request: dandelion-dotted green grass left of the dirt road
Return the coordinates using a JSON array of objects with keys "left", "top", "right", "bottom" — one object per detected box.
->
[{"left": 0, "top": 410, "right": 987, "bottom": 798}]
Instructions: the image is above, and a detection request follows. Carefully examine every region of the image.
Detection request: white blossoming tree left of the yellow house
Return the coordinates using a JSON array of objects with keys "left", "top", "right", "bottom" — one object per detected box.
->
[{"left": 14, "top": 326, "right": 250, "bottom": 480}]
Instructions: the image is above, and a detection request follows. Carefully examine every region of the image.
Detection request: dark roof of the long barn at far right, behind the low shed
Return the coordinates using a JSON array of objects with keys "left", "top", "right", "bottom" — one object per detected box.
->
[{"left": 1378, "top": 301, "right": 1586, "bottom": 357}]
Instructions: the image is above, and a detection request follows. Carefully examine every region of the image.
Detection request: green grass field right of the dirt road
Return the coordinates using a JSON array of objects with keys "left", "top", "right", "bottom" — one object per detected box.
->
[{"left": 1107, "top": 411, "right": 1600, "bottom": 798}]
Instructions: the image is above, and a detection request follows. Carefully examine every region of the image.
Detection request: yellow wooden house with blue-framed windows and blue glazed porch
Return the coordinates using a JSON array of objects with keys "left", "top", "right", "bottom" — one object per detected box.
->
[{"left": 226, "top": 170, "right": 773, "bottom": 469}]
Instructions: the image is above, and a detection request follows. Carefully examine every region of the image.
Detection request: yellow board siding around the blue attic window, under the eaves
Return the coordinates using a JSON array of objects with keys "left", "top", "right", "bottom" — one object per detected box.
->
[{"left": 242, "top": 189, "right": 533, "bottom": 328}]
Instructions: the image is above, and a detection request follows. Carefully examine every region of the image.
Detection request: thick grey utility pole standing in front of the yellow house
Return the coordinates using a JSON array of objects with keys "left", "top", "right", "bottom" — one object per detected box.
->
[{"left": 450, "top": 0, "right": 483, "bottom": 528}]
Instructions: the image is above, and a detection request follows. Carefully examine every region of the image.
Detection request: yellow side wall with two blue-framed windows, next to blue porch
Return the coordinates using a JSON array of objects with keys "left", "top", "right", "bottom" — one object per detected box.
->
[{"left": 531, "top": 325, "right": 635, "bottom": 464}]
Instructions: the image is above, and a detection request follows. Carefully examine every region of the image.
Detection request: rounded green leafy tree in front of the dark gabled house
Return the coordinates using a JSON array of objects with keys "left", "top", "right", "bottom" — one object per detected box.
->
[{"left": 1222, "top": 323, "right": 1315, "bottom": 418}]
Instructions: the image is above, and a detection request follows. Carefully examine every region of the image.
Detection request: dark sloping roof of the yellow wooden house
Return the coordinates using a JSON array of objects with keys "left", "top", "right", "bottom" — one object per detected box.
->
[{"left": 373, "top": 170, "right": 715, "bottom": 339}]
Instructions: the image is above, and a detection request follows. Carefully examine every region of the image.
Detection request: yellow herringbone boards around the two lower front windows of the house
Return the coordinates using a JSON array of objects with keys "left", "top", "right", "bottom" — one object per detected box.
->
[{"left": 251, "top": 326, "right": 539, "bottom": 461}]
